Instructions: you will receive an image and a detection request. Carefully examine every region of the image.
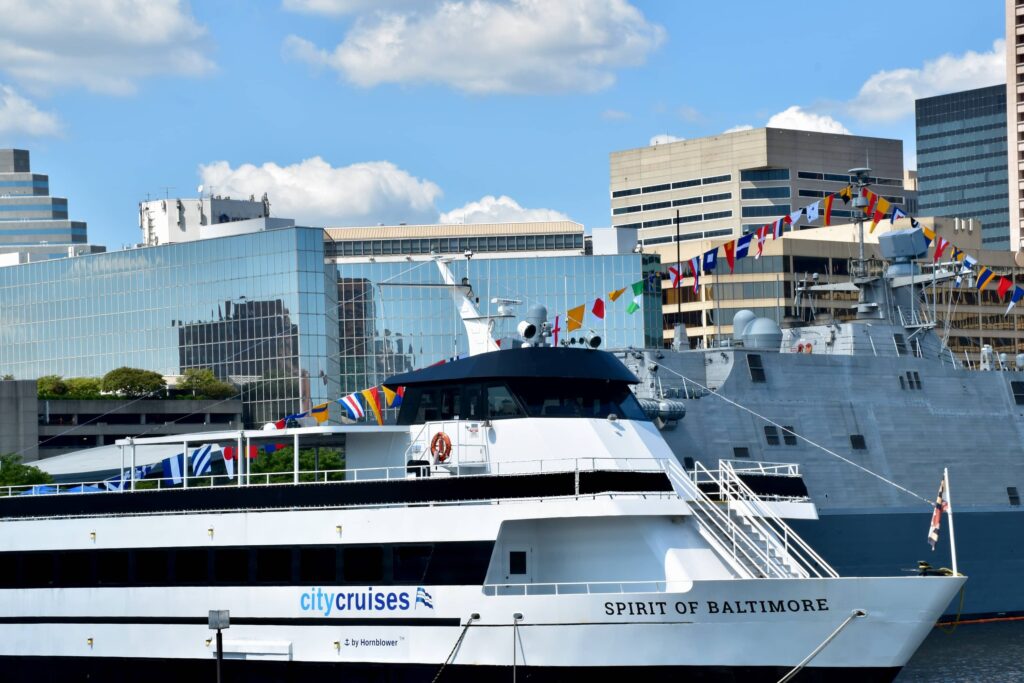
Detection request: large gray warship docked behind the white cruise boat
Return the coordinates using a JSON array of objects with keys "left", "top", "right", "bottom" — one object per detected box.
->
[{"left": 618, "top": 228, "right": 1024, "bottom": 615}]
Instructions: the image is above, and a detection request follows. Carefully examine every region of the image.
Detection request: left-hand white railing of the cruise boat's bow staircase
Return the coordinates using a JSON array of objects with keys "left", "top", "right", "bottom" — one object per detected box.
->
[{"left": 663, "top": 458, "right": 794, "bottom": 579}]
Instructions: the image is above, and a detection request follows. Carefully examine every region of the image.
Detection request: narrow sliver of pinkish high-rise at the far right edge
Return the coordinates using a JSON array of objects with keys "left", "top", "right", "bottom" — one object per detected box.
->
[{"left": 1006, "top": 0, "right": 1024, "bottom": 252}]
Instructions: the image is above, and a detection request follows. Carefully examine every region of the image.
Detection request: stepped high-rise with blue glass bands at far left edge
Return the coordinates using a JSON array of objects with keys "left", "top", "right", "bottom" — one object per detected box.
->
[{"left": 0, "top": 150, "right": 87, "bottom": 257}]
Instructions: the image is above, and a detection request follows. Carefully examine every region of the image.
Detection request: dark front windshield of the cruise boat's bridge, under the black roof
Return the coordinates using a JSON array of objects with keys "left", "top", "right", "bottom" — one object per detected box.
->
[{"left": 509, "top": 379, "right": 649, "bottom": 421}]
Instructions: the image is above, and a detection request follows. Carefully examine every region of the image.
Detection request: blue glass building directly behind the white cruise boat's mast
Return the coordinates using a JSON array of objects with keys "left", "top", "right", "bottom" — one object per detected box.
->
[{"left": 338, "top": 254, "right": 662, "bottom": 392}]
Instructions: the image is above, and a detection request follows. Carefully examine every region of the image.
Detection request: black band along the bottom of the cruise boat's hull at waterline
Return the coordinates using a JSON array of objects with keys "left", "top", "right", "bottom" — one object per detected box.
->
[{"left": 0, "top": 655, "right": 899, "bottom": 683}]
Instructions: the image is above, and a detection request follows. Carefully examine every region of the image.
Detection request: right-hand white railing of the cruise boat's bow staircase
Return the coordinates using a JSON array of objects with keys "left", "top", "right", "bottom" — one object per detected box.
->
[{"left": 719, "top": 461, "right": 839, "bottom": 578}]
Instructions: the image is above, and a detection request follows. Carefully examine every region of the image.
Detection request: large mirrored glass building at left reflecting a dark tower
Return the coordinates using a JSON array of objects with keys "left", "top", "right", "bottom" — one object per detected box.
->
[{"left": 0, "top": 227, "right": 339, "bottom": 425}]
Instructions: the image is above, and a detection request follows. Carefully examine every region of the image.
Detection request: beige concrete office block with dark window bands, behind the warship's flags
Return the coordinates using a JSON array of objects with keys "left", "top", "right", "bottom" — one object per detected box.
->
[{"left": 610, "top": 128, "right": 915, "bottom": 255}]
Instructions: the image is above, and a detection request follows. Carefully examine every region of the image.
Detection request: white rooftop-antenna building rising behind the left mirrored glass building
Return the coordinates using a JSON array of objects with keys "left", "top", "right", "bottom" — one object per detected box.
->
[{"left": 138, "top": 194, "right": 295, "bottom": 247}]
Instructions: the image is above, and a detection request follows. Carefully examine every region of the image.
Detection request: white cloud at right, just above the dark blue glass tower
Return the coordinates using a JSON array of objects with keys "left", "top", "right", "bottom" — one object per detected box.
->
[{"left": 847, "top": 38, "right": 1007, "bottom": 121}]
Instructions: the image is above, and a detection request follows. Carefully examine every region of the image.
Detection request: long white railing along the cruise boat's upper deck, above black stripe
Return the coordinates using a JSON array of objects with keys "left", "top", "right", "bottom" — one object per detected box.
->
[{"left": 0, "top": 457, "right": 664, "bottom": 497}]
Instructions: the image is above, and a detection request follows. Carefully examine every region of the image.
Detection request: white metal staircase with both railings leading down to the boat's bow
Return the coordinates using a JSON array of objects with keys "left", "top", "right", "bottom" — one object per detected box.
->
[{"left": 664, "top": 459, "right": 839, "bottom": 579}]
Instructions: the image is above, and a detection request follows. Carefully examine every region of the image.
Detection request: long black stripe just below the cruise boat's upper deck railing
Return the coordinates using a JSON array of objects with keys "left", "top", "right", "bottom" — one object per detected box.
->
[{"left": 0, "top": 471, "right": 672, "bottom": 518}]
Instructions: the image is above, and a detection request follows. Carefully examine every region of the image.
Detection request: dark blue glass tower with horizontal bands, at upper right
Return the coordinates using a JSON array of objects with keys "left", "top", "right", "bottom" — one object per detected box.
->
[{"left": 915, "top": 84, "right": 1011, "bottom": 249}]
